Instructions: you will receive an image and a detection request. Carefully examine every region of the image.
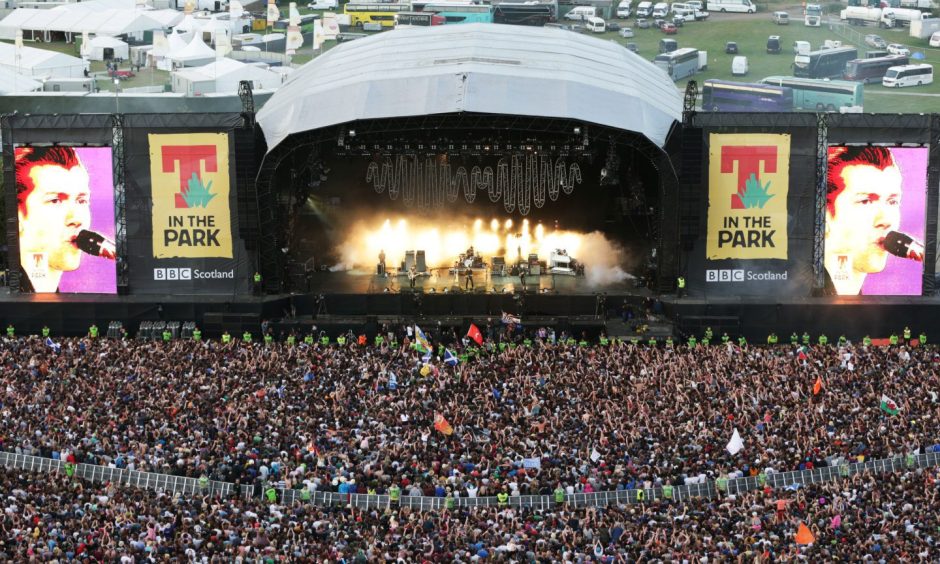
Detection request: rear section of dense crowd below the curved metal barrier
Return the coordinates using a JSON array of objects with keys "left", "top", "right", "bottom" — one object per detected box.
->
[{"left": 0, "top": 462, "right": 940, "bottom": 563}]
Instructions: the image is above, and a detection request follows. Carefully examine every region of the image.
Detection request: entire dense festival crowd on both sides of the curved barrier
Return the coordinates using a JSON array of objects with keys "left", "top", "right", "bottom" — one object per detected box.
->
[{"left": 0, "top": 332, "right": 940, "bottom": 562}]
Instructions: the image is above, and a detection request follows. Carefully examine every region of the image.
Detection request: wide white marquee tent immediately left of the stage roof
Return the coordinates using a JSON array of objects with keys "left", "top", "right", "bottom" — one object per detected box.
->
[{"left": 173, "top": 58, "right": 282, "bottom": 96}]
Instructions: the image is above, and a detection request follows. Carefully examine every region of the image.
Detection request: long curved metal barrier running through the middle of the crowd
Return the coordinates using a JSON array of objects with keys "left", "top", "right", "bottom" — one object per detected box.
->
[{"left": 0, "top": 452, "right": 940, "bottom": 511}]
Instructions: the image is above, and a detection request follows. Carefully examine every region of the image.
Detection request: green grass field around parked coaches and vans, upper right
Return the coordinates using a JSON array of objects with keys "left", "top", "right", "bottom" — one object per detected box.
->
[{"left": 600, "top": 11, "right": 940, "bottom": 113}]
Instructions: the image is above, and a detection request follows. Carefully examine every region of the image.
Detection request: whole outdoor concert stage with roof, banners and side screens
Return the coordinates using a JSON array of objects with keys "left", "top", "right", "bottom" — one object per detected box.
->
[{"left": 0, "top": 25, "right": 940, "bottom": 339}]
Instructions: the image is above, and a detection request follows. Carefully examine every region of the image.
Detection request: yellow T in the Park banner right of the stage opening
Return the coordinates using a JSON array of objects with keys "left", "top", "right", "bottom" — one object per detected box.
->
[{"left": 706, "top": 133, "right": 790, "bottom": 260}]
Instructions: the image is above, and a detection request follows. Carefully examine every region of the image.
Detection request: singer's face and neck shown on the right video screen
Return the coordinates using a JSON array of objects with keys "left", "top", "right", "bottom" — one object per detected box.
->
[{"left": 826, "top": 164, "right": 901, "bottom": 274}]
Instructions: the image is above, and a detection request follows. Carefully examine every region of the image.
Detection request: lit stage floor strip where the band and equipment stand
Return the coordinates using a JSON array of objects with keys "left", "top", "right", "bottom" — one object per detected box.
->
[{"left": 295, "top": 268, "right": 649, "bottom": 295}]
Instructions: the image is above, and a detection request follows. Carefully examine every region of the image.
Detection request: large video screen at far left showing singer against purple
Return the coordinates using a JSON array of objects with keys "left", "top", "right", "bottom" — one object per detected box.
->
[{"left": 15, "top": 146, "right": 117, "bottom": 294}]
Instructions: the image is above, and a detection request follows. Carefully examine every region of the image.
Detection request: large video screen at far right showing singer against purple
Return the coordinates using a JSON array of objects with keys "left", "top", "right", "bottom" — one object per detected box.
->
[{"left": 825, "top": 146, "right": 927, "bottom": 296}]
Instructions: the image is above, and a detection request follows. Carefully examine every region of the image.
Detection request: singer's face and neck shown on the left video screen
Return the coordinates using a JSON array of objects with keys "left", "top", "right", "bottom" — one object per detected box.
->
[{"left": 19, "top": 165, "right": 91, "bottom": 271}]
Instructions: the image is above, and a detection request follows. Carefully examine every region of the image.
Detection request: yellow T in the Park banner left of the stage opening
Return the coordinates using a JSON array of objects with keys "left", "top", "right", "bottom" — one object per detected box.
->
[{"left": 149, "top": 133, "right": 232, "bottom": 258}]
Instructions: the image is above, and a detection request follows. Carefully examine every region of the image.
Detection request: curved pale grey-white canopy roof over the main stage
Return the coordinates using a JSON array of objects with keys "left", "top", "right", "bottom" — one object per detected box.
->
[{"left": 258, "top": 24, "right": 682, "bottom": 150}]
